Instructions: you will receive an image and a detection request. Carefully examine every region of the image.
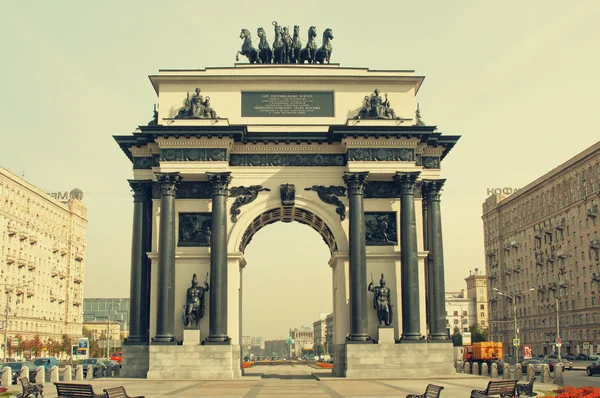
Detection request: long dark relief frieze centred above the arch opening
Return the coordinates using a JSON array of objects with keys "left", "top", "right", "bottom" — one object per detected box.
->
[{"left": 229, "top": 153, "right": 346, "bottom": 167}]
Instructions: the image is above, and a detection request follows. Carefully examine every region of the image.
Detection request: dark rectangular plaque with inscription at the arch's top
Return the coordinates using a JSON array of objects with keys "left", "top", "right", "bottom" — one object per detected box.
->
[{"left": 242, "top": 91, "right": 334, "bottom": 117}]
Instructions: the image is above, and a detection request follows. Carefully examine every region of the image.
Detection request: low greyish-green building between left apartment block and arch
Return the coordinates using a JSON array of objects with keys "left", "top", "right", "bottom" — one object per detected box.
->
[{"left": 83, "top": 298, "right": 129, "bottom": 337}]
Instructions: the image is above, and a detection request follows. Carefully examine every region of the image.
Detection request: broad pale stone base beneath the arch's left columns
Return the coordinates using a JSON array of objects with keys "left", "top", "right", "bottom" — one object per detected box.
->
[{"left": 147, "top": 345, "right": 242, "bottom": 380}]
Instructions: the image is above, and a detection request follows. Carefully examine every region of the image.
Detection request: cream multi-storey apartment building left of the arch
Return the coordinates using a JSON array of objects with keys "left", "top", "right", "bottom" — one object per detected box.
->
[{"left": 0, "top": 167, "right": 87, "bottom": 348}]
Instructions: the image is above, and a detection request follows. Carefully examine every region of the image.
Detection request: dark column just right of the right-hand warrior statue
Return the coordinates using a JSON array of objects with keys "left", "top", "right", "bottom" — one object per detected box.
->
[{"left": 394, "top": 172, "right": 424, "bottom": 343}]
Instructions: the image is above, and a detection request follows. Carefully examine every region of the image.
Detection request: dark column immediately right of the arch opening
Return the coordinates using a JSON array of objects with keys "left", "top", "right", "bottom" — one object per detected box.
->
[{"left": 344, "top": 172, "right": 371, "bottom": 343}]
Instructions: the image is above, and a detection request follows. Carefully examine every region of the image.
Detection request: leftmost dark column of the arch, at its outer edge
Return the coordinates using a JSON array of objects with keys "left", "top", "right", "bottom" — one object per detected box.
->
[{"left": 127, "top": 180, "right": 152, "bottom": 344}]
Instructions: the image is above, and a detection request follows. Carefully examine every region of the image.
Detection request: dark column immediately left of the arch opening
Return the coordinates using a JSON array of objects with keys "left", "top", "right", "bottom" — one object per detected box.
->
[{"left": 206, "top": 172, "right": 231, "bottom": 344}]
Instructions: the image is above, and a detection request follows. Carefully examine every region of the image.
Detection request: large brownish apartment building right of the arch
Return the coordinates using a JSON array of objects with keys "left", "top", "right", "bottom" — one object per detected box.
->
[{"left": 482, "top": 143, "right": 600, "bottom": 354}]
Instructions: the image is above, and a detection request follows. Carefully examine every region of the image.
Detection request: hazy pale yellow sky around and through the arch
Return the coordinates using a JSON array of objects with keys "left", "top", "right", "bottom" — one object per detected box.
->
[{"left": 0, "top": 0, "right": 600, "bottom": 337}]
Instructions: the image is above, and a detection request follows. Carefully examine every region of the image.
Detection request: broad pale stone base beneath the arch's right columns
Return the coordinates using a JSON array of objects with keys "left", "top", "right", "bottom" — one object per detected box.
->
[{"left": 335, "top": 342, "right": 455, "bottom": 379}]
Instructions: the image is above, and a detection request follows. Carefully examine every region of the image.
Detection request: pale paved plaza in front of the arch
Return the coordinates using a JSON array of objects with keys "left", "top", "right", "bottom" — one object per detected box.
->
[{"left": 30, "top": 365, "right": 557, "bottom": 398}]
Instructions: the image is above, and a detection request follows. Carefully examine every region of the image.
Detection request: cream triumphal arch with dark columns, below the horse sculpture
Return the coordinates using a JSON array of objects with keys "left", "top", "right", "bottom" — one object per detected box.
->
[{"left": 115, "top": 32, "right": 459, "bottom": 380}]
